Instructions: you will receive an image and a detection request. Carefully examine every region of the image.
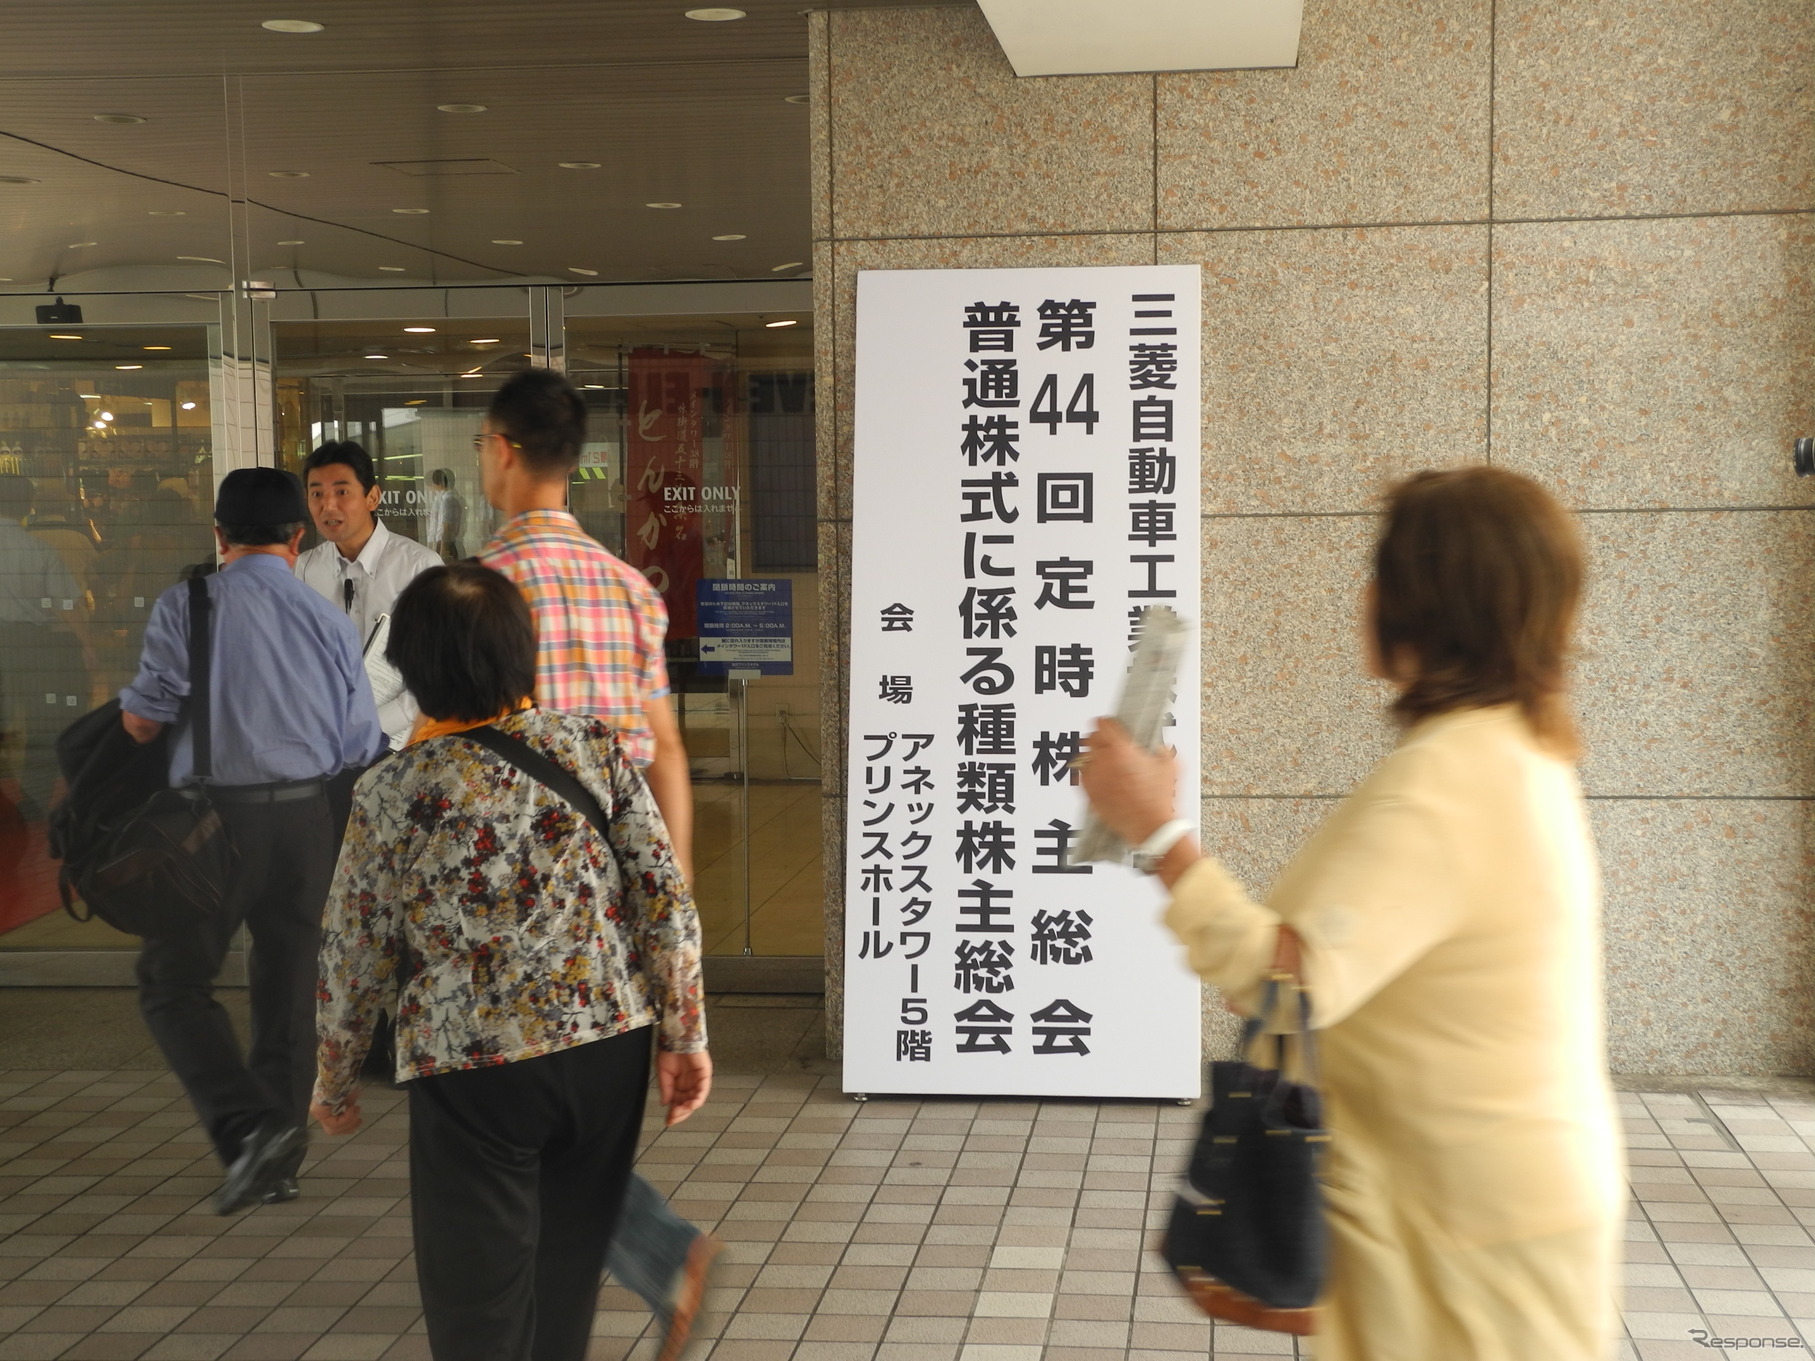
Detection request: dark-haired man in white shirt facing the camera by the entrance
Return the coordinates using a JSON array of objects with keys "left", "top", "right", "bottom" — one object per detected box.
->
[{"left": 296, "top": 441, "right": 441, "bottom": 751}]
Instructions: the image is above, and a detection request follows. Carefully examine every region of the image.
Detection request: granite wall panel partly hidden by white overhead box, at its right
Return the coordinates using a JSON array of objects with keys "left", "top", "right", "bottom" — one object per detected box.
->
[{"left": 1158, "top": 0, "right": 1492, "bottom": 230}]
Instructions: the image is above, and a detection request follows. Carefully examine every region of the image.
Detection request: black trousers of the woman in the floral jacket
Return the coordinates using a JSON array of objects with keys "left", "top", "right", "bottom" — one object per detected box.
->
[{"left": 407, "top": 1029, "right": 650, "bottom": 1361}]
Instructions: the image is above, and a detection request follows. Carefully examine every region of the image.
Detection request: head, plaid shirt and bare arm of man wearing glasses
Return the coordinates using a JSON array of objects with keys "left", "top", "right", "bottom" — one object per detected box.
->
[{"left": 474, "top": 368, "right": 693, "bottom": 880}]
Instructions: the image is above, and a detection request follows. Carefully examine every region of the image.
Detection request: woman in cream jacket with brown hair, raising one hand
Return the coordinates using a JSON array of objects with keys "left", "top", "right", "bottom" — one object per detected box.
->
[{"left": 1084, "top": 466, "right": 1626, "bottom": 1361}]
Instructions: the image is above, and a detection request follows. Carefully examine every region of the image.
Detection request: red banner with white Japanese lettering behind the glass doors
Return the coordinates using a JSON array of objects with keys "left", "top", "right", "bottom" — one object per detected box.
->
[{"left": 624, "top": 348, "right": 719, "bottom": 639}]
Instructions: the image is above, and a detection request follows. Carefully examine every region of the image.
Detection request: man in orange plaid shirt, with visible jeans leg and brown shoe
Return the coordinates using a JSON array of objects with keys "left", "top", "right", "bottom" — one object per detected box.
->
[{"left": 474, "top": 368, "right": 722, "bottom": 1361}]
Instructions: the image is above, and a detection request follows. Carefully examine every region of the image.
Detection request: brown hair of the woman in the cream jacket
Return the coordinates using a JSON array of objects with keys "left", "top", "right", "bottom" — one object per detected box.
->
[{"left": 1374, "top": 465, "right": 1583, "bottom": 757}]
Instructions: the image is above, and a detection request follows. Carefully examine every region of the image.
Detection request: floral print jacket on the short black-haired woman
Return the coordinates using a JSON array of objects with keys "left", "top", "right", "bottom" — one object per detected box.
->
[{"left": 316, "top": 710, "right": 706, "bottom": 1105}]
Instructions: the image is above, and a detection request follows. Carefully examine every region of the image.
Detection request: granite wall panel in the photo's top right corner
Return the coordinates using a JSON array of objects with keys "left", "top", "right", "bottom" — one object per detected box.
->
[{"left": 1488, "top": 0, "right": 1815, "bottom": 218}]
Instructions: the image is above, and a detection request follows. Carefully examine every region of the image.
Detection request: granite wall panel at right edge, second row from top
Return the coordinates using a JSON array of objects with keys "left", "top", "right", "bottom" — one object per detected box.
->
[{"left": 1494, "top": 215, "right": 1815, "bottom": 508}]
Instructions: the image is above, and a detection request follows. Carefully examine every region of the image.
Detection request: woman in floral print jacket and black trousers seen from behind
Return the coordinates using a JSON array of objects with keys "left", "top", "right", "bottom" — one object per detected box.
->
[{"left": 314, "top": 564, "right": 711, "bottom": 1361}]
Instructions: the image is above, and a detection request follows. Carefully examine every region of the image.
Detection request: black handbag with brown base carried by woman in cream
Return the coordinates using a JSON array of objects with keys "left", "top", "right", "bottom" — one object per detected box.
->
[{"left": 1160, "top": 969, "right": 1330, "bottom": 1336}]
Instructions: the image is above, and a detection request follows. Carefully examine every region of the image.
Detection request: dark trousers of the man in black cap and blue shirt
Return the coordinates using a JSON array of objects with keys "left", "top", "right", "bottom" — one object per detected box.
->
[{"left": 138, "top": 793, "right": 334, "bottom": 1163}]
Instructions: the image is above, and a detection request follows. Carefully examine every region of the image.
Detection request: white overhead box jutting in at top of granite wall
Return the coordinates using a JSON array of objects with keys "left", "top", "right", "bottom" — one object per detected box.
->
[{"left": 976, "top": 0, "right": 1305, "bottom": 76}]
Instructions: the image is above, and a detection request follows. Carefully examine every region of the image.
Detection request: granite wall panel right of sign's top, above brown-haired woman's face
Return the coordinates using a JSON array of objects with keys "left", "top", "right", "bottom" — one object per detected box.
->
[{"left": 1160, "top": 227, "right": 1488, "bottom": 514}]
